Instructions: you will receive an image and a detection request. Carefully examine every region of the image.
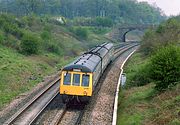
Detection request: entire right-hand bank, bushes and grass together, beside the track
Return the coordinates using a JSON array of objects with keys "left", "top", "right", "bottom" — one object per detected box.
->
[{"left": 118, "top": 16, "right": 180, "bottom": 125}]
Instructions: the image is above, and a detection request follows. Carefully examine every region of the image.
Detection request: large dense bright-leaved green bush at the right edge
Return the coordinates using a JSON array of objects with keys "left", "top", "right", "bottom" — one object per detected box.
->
[{"left": 151, "top": 45, "right": 180, "bottom": 91}]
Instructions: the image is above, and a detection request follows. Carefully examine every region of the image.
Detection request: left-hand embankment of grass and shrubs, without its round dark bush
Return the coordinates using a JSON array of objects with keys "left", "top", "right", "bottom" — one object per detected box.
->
[{"left": 0, "top": 15, "right": 111, "bottom": 109}]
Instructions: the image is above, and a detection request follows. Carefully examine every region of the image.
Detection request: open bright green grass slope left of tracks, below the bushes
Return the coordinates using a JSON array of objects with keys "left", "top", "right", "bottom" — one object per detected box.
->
[{"left": 0, "top": 46, "right": 76, "bottom": 109}]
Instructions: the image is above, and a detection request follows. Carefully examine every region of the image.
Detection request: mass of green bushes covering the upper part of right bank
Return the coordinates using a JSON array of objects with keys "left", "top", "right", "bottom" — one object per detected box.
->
[{"left": 127, "top": 17, "right": 180, "bottom": 91}]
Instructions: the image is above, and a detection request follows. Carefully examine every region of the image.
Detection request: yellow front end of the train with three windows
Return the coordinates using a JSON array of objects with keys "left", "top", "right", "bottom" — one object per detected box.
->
[{"left": 60, "top": 71, "right": 93, "bottom": 102}]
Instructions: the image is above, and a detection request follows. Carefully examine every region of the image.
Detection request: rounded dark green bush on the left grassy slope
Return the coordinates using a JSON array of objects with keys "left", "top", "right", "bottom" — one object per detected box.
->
[{"left": 20, "top": 34, "right": 40, "bottom": 55}]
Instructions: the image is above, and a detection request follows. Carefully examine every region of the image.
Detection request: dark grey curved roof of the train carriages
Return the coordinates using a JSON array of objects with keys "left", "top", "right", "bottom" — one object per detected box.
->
[{"left": 63, "top": 43, "right": 113, "bottom": 72}]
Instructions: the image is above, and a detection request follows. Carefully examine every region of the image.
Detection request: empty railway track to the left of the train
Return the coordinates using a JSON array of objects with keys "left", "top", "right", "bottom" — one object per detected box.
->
[{"left": 4, "top": 78, "right": 60, "bottom": 125}]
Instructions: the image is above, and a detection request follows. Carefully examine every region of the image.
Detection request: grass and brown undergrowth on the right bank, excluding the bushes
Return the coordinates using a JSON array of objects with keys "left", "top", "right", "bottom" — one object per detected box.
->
[{"left": 117, "top": 52, "right": 180, "bottom": 125}]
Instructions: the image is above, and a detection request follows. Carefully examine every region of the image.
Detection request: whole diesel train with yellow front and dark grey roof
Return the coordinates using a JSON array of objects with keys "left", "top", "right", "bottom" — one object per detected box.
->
[{"left": 60, "top": 43, "right": 114, "bottom": 102}]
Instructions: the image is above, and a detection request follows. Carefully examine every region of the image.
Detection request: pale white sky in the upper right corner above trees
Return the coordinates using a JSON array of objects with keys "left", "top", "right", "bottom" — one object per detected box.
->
[{"left": 137, "top": 0, "right": 180, "bottom": 16}]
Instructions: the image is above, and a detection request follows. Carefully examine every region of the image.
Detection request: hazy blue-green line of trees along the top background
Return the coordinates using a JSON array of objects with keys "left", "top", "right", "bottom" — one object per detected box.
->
[{"left": 0, "top": 0, "right": 165, "bottom": 24}]
